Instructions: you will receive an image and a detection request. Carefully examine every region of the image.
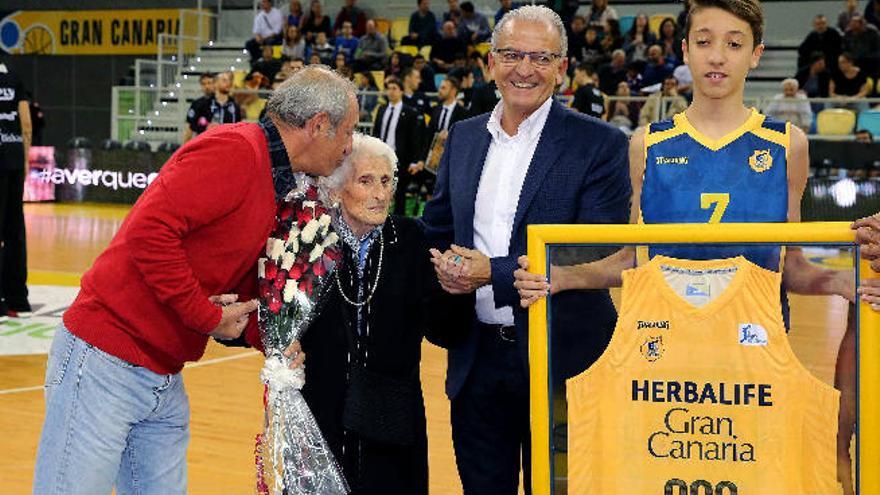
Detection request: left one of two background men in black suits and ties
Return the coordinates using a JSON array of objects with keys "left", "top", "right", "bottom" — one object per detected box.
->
[{"left": 373, "top": 78, "right": 425, "bottom": 215}]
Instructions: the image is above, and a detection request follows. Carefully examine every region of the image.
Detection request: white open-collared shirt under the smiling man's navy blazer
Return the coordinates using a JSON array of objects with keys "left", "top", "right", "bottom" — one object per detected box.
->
[{"left": 474, "top": 98, "right": 553, "bottom": 325}]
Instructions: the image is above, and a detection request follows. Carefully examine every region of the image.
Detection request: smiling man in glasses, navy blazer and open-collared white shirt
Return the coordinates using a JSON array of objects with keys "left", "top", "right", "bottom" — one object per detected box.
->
[{"left": 422, "top": 6, "right": 631, "bottom": 495}]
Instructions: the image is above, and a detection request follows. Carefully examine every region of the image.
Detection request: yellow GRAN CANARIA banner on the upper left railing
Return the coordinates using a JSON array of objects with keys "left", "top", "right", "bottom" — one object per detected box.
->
[{"left": 0, "top": 9, "right": 208, "bottom": 55}]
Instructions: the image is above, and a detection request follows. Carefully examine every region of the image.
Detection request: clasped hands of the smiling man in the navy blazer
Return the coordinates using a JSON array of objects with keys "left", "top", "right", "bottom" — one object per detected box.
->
[{"left": 431, "top": 244, "right": 492, "bottom": 294}]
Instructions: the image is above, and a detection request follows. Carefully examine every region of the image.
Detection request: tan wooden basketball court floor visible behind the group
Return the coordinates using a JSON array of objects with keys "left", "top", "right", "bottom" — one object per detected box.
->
[{"left": 0, "top": 204, "right": 846, "bottom": 495}]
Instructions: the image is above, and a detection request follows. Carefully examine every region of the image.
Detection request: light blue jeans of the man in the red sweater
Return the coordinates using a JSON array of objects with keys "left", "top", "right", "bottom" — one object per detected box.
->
[{"left": 33, "top": 326, "right": 189, "bottom": 495}]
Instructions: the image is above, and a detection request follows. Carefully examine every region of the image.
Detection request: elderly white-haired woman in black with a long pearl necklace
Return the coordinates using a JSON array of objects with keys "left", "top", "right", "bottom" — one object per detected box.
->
[{"left": 302, "top": 134, "right": 473, "bottom": 495}]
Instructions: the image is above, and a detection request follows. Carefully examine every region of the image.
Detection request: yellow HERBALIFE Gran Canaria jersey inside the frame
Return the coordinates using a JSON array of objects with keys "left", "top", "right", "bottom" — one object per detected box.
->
[{"left": 567, "top": 255, "right": 841, "bottom": 495}]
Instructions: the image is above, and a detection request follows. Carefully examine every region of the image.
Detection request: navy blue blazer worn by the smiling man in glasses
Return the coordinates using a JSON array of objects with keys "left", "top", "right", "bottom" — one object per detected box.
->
[{"left": 422, "top": 101, "right": 631, "bottom": 398}]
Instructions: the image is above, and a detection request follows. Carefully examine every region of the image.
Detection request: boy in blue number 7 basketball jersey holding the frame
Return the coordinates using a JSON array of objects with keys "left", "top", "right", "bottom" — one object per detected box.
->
[{"left": 514, "top": 0, "right": 878, "bottom": 492}]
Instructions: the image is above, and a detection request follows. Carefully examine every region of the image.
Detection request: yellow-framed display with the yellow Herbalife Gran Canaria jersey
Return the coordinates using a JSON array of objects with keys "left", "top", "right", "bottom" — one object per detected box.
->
[{"left": 528, "top": 222, "right": 880, "bottom": 495}]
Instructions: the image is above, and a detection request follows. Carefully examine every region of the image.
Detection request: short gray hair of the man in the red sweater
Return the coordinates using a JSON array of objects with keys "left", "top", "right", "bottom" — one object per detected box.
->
[{"left": 266, "top": 65, "right": 357, "bottom": 129}]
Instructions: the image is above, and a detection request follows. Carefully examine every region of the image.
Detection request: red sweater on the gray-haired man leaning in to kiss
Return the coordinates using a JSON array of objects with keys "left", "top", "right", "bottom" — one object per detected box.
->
[{"left": 64, "top": 124, "right": 275, "bottom": 374}]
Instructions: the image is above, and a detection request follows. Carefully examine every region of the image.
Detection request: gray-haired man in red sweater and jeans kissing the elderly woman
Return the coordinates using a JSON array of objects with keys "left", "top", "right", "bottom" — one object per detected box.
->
[{"left": 33, "top": 67, "right": 358, "bottom": 495}]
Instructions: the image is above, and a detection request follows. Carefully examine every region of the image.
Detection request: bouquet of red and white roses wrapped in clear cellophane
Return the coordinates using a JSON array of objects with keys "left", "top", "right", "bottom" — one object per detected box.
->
[{"left": 256, "top": 175, "right": 348, "bottom": 495}]
